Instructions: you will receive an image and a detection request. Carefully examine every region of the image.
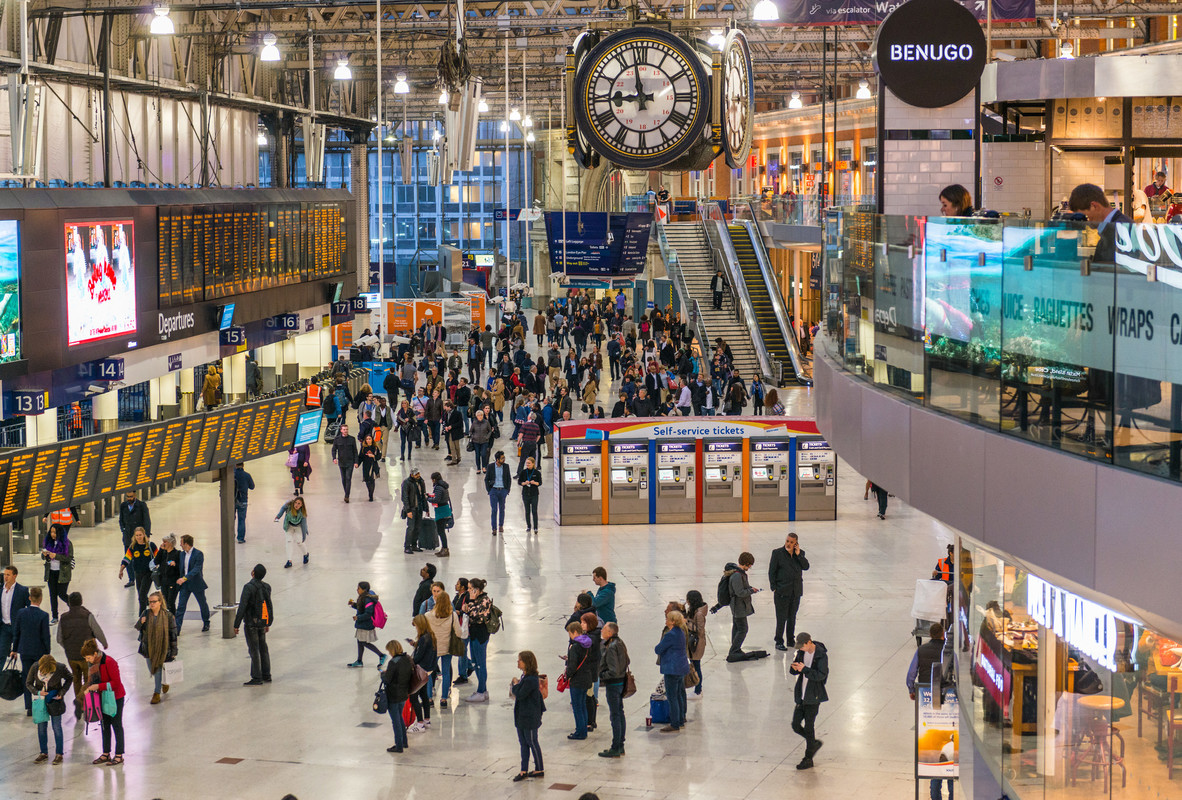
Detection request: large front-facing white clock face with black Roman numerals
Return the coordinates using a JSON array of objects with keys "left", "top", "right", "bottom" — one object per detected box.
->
[{"left": 574, "top": 27, "right": 708, "bottom": 169}]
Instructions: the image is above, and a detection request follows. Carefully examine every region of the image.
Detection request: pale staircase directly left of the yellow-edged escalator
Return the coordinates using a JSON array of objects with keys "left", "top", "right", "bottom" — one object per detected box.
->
[{"left": 664, "top": 222, "right": 760, "bottom": 381}]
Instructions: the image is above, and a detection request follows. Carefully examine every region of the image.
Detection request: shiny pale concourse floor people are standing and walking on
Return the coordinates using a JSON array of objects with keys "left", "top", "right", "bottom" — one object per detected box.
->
[{"left": 0, "top": 382, "right": 952, "bottom": 800}]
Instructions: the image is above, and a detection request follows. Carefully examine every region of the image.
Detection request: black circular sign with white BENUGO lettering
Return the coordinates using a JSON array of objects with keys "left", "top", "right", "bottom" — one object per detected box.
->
[{"left": 873, "top": 0, "right": 986, "bottom": 109}]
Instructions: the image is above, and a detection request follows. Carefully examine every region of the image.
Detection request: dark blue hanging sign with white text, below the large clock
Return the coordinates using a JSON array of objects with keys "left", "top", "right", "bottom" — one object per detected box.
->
[{"left": 545, "top": 212, "right": 652, "bottom": 280}]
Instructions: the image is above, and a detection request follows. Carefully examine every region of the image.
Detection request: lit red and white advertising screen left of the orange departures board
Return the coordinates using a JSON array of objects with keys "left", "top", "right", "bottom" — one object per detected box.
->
[{"left": 65, "top": 220, "right": 136, "bottom": 346}]
